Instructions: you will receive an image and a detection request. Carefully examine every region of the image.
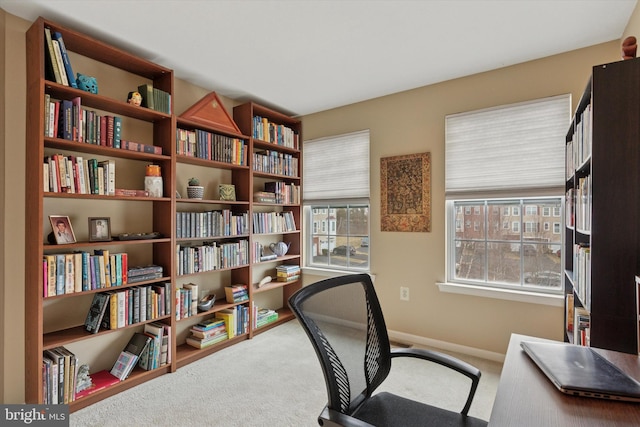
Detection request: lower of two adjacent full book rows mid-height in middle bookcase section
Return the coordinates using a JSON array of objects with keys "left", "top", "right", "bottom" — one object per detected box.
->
[{"left": 176, "top": 240, "right": 249, "bottom": 276}]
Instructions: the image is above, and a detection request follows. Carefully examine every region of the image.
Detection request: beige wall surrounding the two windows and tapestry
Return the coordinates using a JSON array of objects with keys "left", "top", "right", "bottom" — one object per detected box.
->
[{"left": 303, "top": 34, "right": 640, "bottom": 354}]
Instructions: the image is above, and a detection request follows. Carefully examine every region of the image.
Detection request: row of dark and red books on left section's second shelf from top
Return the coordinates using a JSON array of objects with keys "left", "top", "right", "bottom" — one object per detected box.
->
[{"left": 44, "top": 94, "right": 162, "bottom": 154}]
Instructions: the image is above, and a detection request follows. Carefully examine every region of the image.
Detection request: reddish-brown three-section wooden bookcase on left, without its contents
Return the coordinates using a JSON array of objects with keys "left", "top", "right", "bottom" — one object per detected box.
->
[{"left": 25, "top": 18, "right": 302, "bottom": 411}]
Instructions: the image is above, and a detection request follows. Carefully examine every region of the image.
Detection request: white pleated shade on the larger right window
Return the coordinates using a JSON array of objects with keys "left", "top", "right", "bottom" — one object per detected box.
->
[{"left": 445, "top": 95, "right": 571, "bottom": 198}]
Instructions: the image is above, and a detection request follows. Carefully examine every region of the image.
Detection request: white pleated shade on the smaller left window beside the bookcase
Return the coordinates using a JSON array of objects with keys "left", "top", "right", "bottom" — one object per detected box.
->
[{"left": 303, "top": 130, "right": 369, "bottom": 202}]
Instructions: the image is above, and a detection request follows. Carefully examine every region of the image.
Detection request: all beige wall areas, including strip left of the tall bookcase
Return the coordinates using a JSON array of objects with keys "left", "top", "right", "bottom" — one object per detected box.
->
[{"left": 0, "top": 4, "right": 640, "bottom": 403}]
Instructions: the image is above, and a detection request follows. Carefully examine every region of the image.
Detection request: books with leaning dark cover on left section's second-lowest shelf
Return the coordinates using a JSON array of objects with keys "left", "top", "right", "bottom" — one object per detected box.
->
[{"left": 84, "top": 283, "right": 171, "bottom": 334}]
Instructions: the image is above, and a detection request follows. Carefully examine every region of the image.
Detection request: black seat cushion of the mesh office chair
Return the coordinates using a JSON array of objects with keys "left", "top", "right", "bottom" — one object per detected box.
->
[{"left": 352, "top": 392, "right": 487, "bottom": 427}]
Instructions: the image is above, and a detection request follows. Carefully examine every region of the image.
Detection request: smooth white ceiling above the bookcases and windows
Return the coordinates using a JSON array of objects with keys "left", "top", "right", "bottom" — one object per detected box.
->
[{"left": 0, "top": 0, "right": 640, "bottom": 115}]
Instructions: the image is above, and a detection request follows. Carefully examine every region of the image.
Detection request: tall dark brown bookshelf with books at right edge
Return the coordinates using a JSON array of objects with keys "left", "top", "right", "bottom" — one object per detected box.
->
[{"left": 564, "top": 59, "right": 640, "bottom": 354}]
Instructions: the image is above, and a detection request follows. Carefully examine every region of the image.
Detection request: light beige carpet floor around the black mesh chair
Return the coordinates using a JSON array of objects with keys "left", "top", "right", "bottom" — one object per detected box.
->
[{"left": 70, "top": 320, "right": 502, "bottom": 427}]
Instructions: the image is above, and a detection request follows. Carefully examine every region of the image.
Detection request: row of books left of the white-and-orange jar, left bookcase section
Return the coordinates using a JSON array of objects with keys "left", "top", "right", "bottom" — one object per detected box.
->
[{"left": 43, "top": 154, "right": 116, "bottom": 196}]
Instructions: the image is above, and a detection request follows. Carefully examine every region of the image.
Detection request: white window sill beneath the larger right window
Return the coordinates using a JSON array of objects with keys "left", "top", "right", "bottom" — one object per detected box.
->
[{"left": 436, "top": 282, "right": 564, "bottom": 307}]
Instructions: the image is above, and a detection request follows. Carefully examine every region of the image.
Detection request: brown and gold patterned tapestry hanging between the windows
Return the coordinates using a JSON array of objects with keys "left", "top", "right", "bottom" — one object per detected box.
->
[{"left": 380, "top": 153, "right": 431, "bottom": 232}]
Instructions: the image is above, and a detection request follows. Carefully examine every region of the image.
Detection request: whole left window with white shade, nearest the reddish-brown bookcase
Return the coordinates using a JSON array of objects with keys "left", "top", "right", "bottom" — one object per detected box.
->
[{"left": 303, "top": 130, "right": 370, "bottom": 272}]
